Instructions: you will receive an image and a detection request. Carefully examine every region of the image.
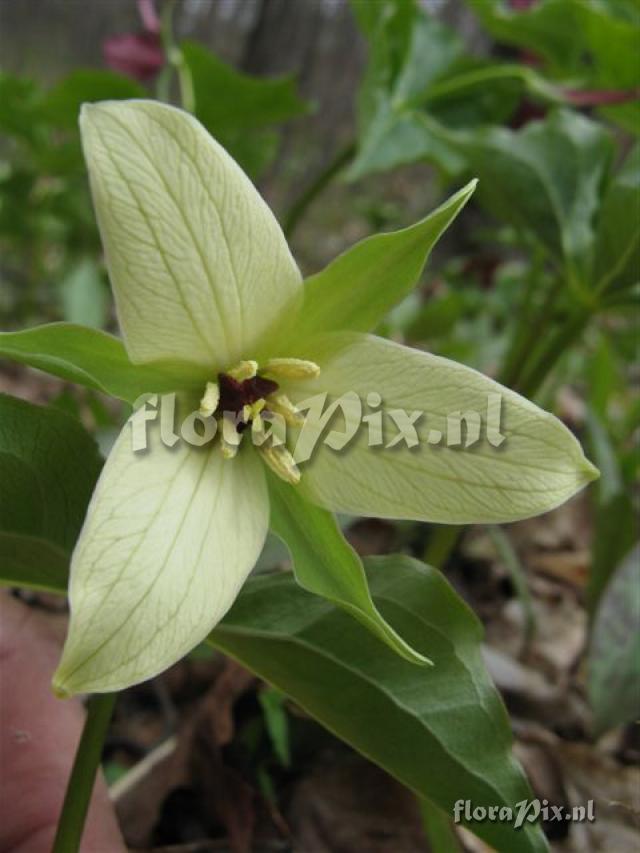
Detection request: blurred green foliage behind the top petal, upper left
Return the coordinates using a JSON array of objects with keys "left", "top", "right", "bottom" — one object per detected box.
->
[{"left": 0, "top": 22, "right": 309, "bottom": 328}]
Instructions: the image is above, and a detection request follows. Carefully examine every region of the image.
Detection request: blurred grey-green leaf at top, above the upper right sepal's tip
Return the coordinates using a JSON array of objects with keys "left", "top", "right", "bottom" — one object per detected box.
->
[{"left": 348, "top": 0, "right": 561, "bottom": 180}]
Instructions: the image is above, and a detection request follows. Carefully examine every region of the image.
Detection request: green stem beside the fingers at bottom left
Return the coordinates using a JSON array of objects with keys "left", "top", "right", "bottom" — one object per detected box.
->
[{"left": 52, "top": 693, "right": 117, "bottom": 853}]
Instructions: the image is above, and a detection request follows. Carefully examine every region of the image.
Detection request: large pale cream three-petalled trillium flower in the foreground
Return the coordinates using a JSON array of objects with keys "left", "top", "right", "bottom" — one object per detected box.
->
[{"left": 54, "top": 101, "right": 597, "bottom": 695}]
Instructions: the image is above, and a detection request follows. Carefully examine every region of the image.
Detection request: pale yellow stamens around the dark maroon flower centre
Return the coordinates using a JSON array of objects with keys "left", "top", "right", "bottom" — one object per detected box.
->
[{"left": 200, "top": 358, "right": 320, "bottom": 485}]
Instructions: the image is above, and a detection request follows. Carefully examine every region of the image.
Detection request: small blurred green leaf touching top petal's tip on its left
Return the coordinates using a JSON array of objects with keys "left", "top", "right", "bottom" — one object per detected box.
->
[{"left": 43, "top": 68, "right": 146, "bottom": 129}]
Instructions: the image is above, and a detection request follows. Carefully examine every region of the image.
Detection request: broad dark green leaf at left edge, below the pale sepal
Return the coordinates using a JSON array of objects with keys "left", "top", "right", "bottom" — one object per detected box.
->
[{"left": 0, "top": 394, "right": 102, "bottom": 587}]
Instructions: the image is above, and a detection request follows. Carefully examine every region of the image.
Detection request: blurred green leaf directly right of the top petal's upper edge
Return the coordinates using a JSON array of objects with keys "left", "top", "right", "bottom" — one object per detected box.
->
[{"left": 181, "top": 41, "right": 308, "bottom": 175}]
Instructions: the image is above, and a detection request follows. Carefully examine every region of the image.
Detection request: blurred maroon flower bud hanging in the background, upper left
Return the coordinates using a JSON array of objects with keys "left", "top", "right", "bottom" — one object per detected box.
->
[{"left": 102, "top": 0, "right": 165, "bottom": 81}]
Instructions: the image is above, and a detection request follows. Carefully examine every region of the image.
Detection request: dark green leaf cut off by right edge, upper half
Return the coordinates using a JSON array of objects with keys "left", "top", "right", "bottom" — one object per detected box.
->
[{"left": 594, "top": 143, "right": 640, "bottom": 289}]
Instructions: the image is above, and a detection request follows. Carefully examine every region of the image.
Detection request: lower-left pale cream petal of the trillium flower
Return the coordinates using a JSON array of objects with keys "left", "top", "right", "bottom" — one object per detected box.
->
[{"left": 54, "top": 424, "right": 269, "bottom": 695}]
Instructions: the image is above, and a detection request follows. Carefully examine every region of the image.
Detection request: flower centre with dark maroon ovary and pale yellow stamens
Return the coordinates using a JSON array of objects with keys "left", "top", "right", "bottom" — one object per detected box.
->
[{"left": 200, "top": 358, "right": 320, "bottom": 485}]
